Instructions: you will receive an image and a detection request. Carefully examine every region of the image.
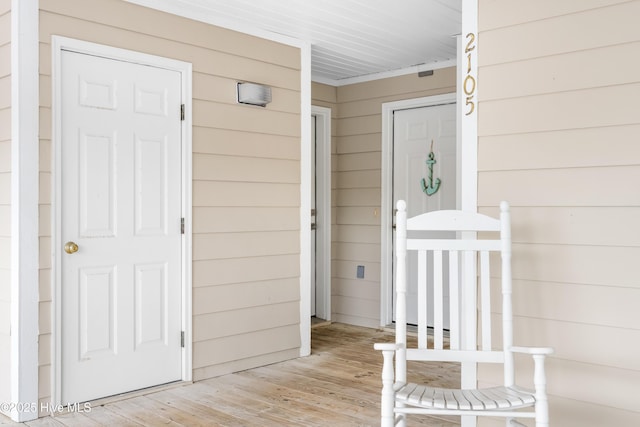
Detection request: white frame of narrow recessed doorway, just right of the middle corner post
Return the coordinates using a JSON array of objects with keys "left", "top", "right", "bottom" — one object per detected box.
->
[{"left": 311, "top": 105, "right": 331, "bottom": 320}]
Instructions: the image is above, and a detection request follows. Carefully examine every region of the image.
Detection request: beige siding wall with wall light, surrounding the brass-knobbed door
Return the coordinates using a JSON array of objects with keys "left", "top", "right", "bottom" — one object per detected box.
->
[{"left": 40, "top": 0, "right": 300, "bottom": 399}]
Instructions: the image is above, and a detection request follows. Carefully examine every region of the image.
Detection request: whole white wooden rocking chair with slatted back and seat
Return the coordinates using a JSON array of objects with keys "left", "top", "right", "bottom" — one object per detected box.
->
[{"left": 374, "top": 201, "right": 553, "bottom": 427}]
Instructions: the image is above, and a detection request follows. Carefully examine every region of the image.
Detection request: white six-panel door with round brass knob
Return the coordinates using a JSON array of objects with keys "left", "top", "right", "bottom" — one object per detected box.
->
[{"left": 59, "top": 51, "right": 182, "bottom": 403}]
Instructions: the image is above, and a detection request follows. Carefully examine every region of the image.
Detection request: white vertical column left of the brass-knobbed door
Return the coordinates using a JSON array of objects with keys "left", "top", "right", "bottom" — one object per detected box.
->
[{"left": 11, "top": 0, "right": 39, "bottom": 421}]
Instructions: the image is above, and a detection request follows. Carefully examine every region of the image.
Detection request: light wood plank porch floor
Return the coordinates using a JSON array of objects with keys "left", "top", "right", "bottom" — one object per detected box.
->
[{"left": 0, "top": 323, "right": 460, "bottom": 427}]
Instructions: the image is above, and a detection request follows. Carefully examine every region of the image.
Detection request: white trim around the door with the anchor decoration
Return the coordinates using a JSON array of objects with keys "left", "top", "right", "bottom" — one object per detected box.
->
[{"left": 380, "top": 92, "right": 458, "bottom": 327}]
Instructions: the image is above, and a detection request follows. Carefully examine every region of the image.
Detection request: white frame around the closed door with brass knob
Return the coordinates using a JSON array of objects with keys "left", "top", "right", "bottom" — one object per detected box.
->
[{"left": 51, "top": 36, "right": 192, "bottom": 404}]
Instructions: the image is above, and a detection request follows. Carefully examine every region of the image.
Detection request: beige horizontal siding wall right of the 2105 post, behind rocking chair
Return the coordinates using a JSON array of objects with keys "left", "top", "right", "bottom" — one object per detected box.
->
[{"left": 478, "top": 0, "right": 640, "bottom": 427}]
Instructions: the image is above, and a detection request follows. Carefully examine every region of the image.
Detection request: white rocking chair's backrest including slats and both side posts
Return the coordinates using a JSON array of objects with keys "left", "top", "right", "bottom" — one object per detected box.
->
[{"left": 396, "top": 201, "right": 514, "bottom": 386}]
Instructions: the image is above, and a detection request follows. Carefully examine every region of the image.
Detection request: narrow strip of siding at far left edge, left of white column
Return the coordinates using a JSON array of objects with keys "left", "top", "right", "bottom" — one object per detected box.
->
[{"left": 0, "top": 0, "right": 11, "bottom": 414}]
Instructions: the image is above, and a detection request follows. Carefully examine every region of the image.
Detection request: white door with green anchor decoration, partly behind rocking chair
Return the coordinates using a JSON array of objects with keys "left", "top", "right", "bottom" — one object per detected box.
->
[{"left": 393, "top": 103, "right": 457, "bottom": 328}]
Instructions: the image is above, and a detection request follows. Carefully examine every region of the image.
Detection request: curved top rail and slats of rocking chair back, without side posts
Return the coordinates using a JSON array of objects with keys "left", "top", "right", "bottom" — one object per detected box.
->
[{"left": 404, "top": 211, "right": 503, "bottom": 351}]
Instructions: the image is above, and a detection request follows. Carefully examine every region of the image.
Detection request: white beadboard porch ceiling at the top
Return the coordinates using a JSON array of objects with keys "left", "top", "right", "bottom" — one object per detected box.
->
[{"left": 129, "top": 0, "right": 462, "bottom": 85}]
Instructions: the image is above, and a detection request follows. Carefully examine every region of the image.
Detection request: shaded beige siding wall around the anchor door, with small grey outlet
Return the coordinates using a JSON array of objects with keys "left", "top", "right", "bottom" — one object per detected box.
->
[{"left": 332, "top": 68, "right": 456, "bottom": 327}]
